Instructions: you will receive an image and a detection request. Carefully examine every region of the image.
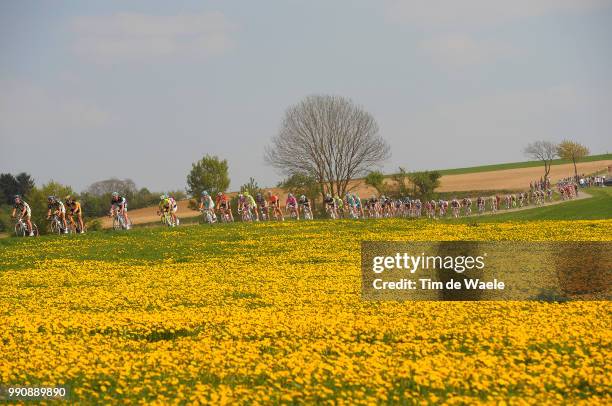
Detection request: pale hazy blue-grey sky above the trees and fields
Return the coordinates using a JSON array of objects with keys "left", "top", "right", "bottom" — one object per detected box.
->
[{"left": 0, "top": 0, "right": 612, "bottom": 190}]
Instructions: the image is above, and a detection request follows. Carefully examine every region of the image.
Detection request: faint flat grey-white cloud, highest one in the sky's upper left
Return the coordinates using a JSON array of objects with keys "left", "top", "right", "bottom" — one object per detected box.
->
[{"left": 72, "top": 12, "right": 235, "bottom": 63}]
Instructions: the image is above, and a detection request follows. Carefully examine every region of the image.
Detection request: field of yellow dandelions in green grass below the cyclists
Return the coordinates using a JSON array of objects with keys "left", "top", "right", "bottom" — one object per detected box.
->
[{"left": 0, "top": 219, "right": 612, "bottom": 404}]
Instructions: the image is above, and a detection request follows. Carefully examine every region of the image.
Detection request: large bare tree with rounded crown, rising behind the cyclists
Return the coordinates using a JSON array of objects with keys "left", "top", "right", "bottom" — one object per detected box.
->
[{"left": 265, "top": 95, "right": 390, "bottom": 195}]
